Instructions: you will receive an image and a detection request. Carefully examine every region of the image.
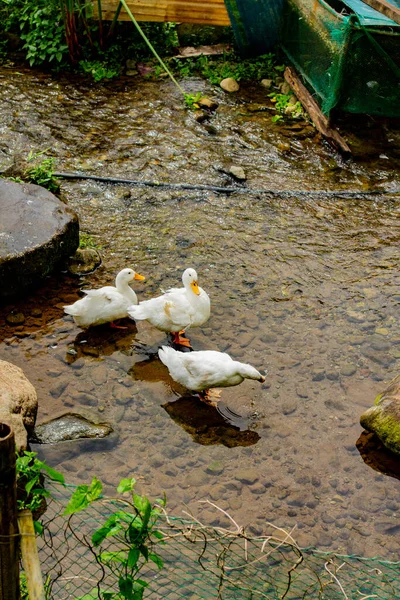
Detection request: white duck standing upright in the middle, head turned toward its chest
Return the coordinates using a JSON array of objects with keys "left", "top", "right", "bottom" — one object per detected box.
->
[{"left": 128, "top": 269, "right": 210, "bottom": 347}]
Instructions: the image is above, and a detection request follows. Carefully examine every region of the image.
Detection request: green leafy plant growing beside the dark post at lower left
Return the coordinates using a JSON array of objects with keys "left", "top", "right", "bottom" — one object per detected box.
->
[{"left": 16, "top": 450, "right": 64, "bottom": 533}]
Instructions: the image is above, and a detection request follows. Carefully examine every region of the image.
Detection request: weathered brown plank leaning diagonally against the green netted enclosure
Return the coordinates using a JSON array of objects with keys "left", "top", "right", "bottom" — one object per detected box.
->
[{"left": 284, "top": 67, "right": 351, "bottom": 154}]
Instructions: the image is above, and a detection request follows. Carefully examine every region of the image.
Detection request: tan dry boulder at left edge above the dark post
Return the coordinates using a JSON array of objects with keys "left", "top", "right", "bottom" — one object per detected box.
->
[{"left": 0, "top": 360, "right": 38, "bottom": 450}]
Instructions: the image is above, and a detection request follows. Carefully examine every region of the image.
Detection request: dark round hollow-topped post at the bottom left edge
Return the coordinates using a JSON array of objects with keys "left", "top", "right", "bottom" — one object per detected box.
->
[{"left": 0, "top": 423, "right": 19, "bottom": 600}]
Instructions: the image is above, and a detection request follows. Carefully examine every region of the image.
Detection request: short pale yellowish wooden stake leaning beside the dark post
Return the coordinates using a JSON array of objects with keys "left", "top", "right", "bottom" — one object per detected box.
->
[{"left": 18, "top": 510, "right": 46, "bottom": 600}]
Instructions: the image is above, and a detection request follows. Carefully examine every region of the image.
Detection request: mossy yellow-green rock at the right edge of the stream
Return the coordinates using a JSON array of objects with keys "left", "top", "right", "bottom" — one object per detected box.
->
[{"left": 360, "top": 375, "right": 400, "bottom": 454}]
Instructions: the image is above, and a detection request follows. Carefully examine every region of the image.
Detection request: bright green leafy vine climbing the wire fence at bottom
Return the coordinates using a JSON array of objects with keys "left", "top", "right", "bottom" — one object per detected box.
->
[{"left": 64, "top": 477, "right": 165, "bottom": 600}]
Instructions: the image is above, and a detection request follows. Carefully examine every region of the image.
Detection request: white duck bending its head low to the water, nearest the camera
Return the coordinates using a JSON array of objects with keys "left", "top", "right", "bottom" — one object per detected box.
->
[{"left": 158, "top": 346, "right": 265, "bottom": 406}]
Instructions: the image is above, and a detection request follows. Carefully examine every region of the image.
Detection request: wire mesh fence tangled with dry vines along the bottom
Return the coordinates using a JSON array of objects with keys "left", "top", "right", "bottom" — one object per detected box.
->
[{"left": 38, "top": 486, "right": 400, "bottom": 600}]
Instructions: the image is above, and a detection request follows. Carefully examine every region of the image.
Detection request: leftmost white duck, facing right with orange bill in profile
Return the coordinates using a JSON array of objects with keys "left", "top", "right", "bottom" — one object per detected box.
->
[{"left": 64, "top": 268, "right": 145, "bottom": 329}]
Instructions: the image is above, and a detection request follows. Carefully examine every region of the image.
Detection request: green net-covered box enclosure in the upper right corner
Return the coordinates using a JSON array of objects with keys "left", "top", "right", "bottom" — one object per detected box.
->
[{"left": 281, "top": 0, "right": 400, "bottom": 117}]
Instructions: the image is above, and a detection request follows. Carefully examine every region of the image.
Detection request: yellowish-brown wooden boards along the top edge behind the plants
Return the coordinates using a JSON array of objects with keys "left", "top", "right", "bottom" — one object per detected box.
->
[{"left": 93, "top": 0, "right": 230, "bottom": 26}]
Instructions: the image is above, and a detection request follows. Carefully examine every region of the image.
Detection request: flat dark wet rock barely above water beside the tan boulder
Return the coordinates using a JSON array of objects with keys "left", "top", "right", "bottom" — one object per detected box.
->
[{"left": 32, "top": 413, "right": 113, "bottom": 444}]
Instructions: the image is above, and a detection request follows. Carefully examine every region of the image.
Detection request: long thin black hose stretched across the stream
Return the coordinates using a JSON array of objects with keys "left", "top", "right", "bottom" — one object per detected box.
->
[{"left": 53, "top": 173, "right": 400, "bottom": 198}]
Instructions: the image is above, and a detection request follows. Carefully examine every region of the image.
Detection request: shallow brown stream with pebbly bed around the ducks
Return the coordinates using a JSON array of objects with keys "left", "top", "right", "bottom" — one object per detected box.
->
[{"left": 0, "top": 66, "right": 400, "bottom": 559}]
